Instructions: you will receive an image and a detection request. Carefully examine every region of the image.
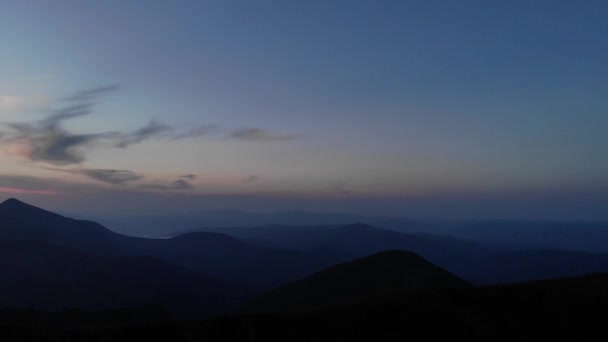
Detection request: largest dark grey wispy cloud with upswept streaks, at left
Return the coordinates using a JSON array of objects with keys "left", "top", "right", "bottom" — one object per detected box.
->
[{"left": 0, "top": 85, "right": 214, "bottom": 165}]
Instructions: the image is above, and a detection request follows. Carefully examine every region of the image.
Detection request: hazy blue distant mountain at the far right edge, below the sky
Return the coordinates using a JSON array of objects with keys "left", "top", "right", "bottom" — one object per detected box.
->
[{"left": 449, "top": 221, "right": 608, "bottom": 253}]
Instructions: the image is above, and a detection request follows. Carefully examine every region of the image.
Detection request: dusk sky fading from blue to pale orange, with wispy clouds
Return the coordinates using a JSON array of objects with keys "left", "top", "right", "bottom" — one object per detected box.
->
[{"left": 0, "top": 0, "right": 608, "bottom": 220}]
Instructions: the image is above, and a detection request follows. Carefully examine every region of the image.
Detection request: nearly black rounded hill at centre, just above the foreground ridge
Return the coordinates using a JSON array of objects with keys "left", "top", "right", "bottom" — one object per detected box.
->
[{"left": 247, "top": 251, "right": 471, "bottom": 311}]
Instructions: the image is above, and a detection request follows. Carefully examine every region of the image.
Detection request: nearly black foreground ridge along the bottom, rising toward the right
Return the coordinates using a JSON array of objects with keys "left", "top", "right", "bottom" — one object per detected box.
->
[{"left": 0, "top": 274, "right": 608, "bottom": 342}]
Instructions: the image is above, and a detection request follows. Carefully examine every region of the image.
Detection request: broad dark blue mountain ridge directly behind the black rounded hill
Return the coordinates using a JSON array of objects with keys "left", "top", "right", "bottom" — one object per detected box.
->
[{"left": 197, "top": 223, "right": 492, "bottom": 280}]
